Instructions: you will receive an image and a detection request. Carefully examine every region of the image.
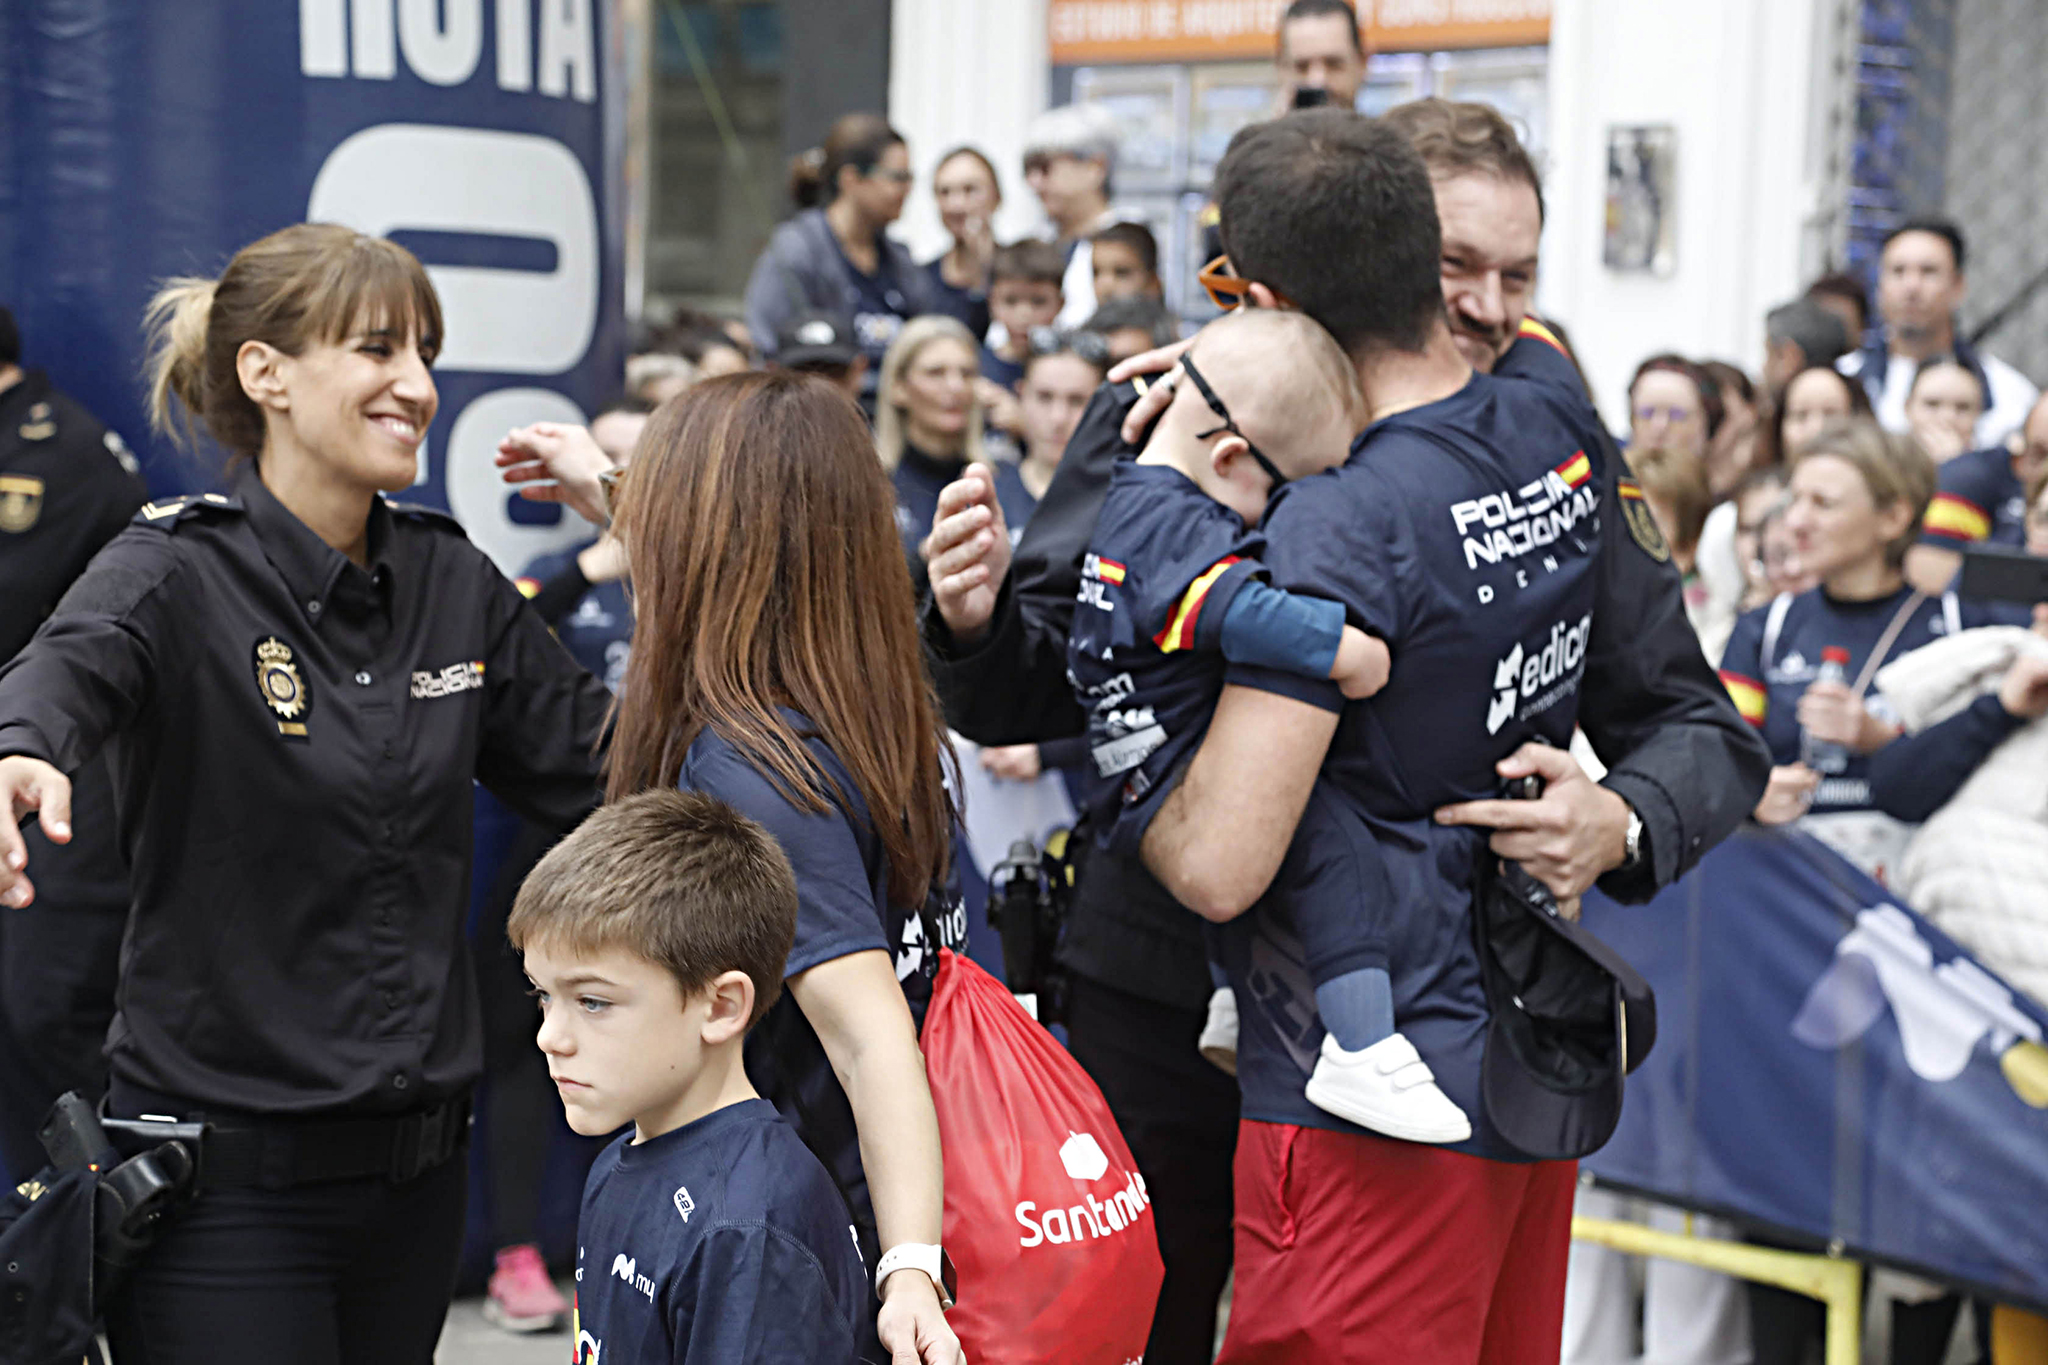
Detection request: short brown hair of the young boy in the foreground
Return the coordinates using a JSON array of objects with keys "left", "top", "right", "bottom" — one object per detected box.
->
[{"left": 506, "top": 788, "right": 797, "bottom": 1027}]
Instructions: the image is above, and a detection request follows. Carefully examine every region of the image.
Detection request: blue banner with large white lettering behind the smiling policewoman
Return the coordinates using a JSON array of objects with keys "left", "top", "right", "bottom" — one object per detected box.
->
[{"left": 0, "top": 0, "right": 623, "bottom": 571}]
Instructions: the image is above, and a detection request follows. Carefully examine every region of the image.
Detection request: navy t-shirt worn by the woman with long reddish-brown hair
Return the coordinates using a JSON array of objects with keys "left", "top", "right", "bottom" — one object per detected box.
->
[{"left": 678, "top": 710, "right": 967, "bottom": 1263}]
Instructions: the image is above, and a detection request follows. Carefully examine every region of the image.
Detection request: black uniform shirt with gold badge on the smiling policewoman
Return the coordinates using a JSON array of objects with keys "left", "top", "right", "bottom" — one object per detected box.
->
[{"left": 0, "top": 465, "right": 610, "bottom": 1113}]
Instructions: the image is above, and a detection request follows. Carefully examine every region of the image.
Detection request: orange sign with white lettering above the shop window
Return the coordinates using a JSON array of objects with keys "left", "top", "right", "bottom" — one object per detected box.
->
[{"left": 1049, "top": 0, "right": 1550, "bottom": 65}]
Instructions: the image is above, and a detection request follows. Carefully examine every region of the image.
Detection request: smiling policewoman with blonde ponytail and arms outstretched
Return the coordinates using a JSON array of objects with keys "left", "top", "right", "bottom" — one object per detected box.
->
[{"left": 0, "top": 225, "right": 608, "bottom": 1365}]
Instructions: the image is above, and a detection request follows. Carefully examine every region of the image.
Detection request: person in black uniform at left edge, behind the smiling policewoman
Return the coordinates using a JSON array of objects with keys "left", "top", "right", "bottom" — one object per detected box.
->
[{"left": 0, "top": 309, "right": 150, "bottom": 1179}]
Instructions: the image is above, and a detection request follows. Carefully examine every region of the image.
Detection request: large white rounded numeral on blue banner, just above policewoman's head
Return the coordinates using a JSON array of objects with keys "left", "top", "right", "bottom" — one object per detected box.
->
[{"left": 305, "top": 123, "right": 600, "bottom": 375}]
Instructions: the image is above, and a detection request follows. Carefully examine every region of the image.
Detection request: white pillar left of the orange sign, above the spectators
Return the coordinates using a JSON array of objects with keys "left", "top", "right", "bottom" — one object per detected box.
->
[{"left": 889, "top": 0, "right": 1051, "bottom": 260}]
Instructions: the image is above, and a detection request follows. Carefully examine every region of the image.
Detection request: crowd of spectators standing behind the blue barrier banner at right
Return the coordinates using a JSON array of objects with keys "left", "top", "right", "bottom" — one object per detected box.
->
[{"left": 1567, "top": 219, "right": 2048, "bottom": 1365}]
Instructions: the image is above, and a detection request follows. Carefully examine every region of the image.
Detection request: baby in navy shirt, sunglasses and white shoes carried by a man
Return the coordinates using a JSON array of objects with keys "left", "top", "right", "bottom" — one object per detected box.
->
[{"left": 1067, "top": 309, "right": 1473, "bottom": 1142}]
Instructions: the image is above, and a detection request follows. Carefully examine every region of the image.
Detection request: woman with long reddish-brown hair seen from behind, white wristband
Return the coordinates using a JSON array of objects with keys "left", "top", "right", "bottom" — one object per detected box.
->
[{"left": 504, "top": 370, "right": 965, "bottom": 1365}]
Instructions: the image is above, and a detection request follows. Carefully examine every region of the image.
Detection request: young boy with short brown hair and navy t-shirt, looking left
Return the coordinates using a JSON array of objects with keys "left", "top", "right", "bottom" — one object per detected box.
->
[{"left": 506, "top": 790, "right": 868, "bottom": 1365}]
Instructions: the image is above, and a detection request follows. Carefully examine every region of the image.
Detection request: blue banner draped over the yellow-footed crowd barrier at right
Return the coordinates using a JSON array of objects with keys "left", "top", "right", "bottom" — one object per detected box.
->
[{"left": 1583, "top": 831, "right": 2048, "bottom": 1308}]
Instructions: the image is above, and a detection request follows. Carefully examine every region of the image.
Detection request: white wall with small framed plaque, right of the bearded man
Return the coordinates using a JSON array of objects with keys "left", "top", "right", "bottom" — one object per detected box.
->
[{"left": 1538, "top": 0, "right": 1831, "bottom": 428}]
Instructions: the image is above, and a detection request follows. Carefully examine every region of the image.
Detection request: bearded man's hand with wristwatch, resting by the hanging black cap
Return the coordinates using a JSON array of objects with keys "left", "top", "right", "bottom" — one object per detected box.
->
[{"left": 1436, "top": 745, "right": 1628, "bottom": 902}]
